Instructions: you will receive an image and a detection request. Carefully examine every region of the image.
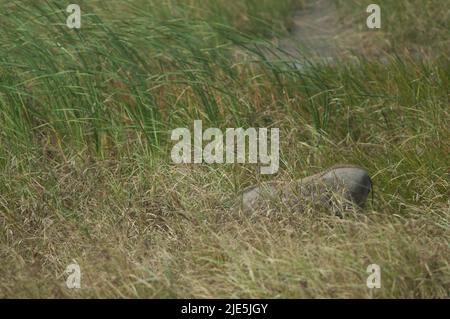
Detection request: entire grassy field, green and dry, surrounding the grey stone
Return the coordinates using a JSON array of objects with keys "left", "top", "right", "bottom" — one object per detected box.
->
[{"left": 0, "top": 0, "right": 450, "bottom": 298}]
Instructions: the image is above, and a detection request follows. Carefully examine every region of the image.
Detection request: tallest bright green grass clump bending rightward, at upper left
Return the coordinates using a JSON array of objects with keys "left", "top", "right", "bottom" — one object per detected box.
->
[{"left": 0, "top": 1, "right": 300, "bottom": 157}]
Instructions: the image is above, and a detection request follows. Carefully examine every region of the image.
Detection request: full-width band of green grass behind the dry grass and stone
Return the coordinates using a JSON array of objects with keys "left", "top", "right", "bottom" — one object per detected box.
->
[{"left": 0, "top": 1, "right": 449, "bottom": 202}]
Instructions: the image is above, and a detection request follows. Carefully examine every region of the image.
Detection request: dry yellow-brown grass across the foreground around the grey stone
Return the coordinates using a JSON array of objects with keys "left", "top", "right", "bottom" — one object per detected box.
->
[{"left": 0, "top": 134, "right": 450, "bottom": 298}]
